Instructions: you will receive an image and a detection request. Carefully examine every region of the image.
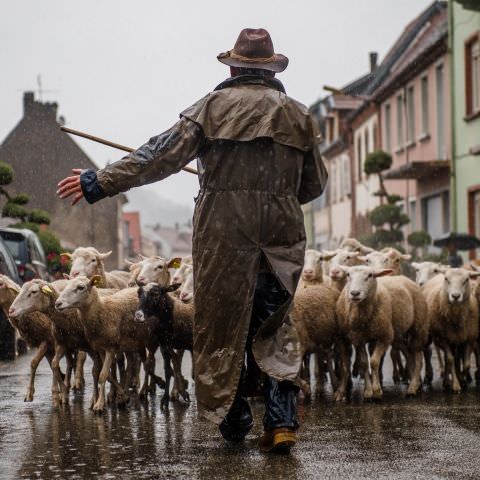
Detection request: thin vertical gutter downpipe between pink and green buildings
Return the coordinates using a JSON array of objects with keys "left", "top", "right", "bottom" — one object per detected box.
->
[{"left": 448, "top": 0, "right": 458, "bottom": 232}]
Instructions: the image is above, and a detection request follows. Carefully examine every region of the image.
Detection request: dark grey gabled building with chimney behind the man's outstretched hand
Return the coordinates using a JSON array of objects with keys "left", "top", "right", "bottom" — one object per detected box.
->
[{"left": 0, "top": 92, "right": 127, "bottom": 269}]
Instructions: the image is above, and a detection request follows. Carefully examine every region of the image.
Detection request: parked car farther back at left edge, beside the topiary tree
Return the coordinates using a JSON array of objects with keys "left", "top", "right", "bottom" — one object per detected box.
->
[{"left": 0, "top": 228, "right": 49, "bottom": 282}]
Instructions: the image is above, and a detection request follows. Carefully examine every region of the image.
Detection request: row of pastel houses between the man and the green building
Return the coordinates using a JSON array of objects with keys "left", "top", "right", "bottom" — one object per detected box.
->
[{"left": 310, "top": 1, "right": 450, "bottom": 248}]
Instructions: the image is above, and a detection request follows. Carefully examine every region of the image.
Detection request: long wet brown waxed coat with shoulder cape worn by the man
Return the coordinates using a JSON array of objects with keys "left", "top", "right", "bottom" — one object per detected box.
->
[{"left": 88, "top": 75, "right": 327, "bottom": 423}]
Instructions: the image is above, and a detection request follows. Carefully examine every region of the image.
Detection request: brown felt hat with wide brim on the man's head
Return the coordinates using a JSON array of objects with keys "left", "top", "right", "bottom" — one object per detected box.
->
[{"left": 217, "top": 28, "right": 288, "bottom": 73}]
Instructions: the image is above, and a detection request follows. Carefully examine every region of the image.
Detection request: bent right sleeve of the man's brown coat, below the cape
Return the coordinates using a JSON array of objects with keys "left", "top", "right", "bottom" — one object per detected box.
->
[{"left": 298, "top": 122, "right": 328, "bottom": 205}]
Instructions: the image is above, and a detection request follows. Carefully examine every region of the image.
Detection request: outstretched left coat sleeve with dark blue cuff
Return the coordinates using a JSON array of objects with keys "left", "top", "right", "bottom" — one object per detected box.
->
[{"left": 80, "top": 117, "right": 205, "bottom": 203}]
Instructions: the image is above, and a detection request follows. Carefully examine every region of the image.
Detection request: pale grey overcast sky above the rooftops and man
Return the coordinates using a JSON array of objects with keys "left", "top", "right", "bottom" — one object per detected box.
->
[{"left": 0, "top": 0, "right": 431, "bottom": 211}]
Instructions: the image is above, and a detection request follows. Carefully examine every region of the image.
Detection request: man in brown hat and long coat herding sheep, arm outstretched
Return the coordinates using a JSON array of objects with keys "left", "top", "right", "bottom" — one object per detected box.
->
[{"left": 57, "top": 28, "right": 327, "bottom": 453}]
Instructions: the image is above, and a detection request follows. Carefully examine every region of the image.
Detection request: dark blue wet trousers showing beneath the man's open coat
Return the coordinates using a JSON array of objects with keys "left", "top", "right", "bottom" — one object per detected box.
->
[{"left": 220, "top": 273, "right": 298, "bottom": 440}]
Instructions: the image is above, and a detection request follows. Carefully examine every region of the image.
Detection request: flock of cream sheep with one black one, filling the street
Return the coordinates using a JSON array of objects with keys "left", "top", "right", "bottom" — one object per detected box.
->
[{"left": 0, "top": 239, "right": 480, "bottom": 413}]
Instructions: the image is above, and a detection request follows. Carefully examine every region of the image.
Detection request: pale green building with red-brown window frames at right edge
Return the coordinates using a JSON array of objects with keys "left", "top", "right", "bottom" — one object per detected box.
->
[{"left": 449, "top": 0, "right": 480, "bottom": 258}]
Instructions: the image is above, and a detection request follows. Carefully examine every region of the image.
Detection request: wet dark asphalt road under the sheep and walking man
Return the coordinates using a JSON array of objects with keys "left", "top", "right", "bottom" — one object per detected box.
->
[{"left": 0, "top": 350, "right": 480, "bottom": 480}]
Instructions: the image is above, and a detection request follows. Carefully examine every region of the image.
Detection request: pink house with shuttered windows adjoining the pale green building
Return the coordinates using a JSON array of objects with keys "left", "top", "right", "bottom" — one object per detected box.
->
[{"left": 373, "top": 4, "right": 450, "bottom": 238}]
